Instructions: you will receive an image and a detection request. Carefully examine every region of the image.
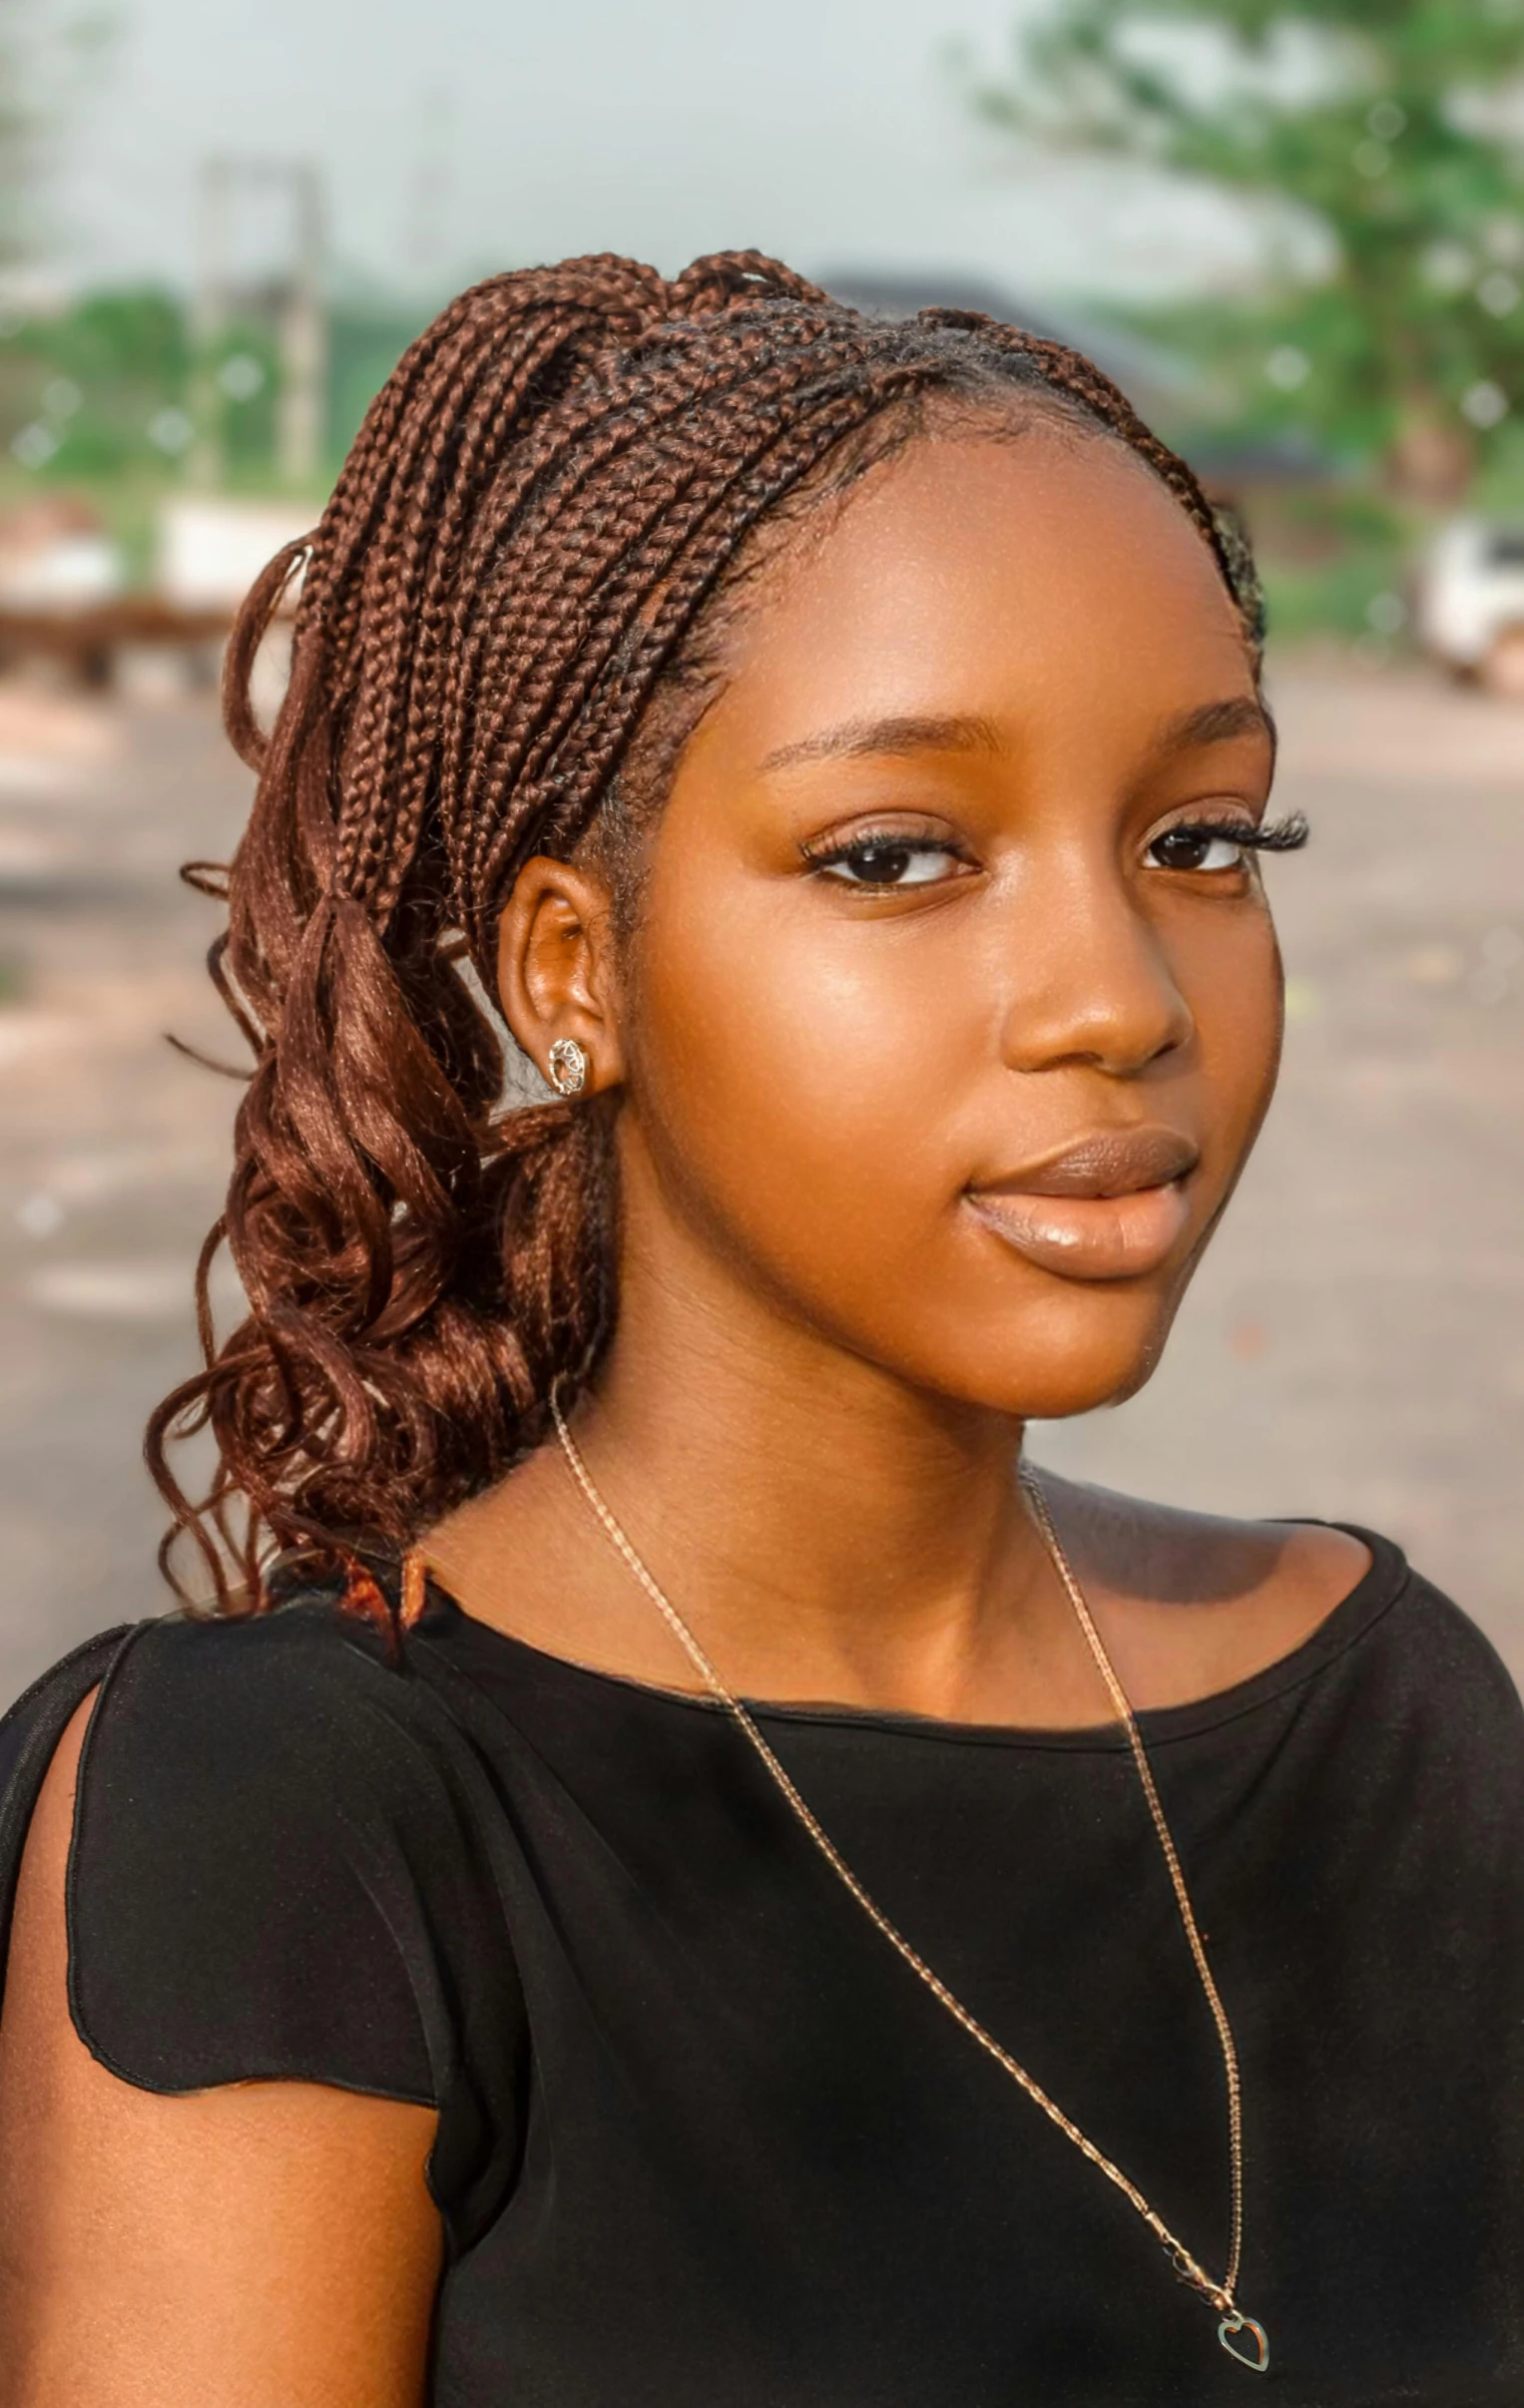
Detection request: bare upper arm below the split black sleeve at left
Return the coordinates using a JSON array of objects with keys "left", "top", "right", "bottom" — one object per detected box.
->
[{"left": 0, "top": 1700, "right": 440, "bottom": 2408}]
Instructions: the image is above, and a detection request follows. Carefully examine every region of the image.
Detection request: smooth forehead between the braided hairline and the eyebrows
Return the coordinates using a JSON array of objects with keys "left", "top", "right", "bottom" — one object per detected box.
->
[{"left": 693, "top": 421, "right": 1255, "bottom": 751}]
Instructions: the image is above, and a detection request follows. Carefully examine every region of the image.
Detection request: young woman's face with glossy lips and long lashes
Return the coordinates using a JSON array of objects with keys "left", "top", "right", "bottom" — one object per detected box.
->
[{"left": 606, "top": 421, "right": 1280, "bottom": 1416}]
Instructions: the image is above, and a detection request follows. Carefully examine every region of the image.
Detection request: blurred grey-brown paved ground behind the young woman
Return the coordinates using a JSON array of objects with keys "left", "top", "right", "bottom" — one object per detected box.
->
[{"left": 0, "top": 663, "right": 1524, "bottom": 1702}]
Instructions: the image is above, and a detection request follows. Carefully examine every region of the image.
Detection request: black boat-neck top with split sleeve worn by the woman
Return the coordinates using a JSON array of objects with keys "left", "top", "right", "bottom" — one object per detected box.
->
[{"left": 0, "top": 1534, "right": 1524, "bottom": 2408}]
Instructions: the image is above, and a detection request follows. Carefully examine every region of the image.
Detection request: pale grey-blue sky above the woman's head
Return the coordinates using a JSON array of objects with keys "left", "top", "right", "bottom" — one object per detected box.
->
[{"left": 53, "top": 0, "right": 1245, "bottom": 310}]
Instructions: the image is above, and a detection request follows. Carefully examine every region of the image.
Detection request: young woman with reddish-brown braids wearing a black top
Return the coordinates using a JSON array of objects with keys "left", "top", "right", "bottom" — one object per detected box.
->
[{"left": 0, "top": 255, "right": 1524, "bottom": 2408}]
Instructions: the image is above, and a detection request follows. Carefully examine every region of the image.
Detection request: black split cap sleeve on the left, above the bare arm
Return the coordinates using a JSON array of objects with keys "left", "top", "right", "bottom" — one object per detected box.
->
[{"left": 0, "top": 1604, "right": 522, "bottom": 2244}]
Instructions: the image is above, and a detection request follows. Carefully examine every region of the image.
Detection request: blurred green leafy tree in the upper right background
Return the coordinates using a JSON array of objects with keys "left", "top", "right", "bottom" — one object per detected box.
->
[{"left": 975, "top": 0, "right": 1524, "bottom": 503}]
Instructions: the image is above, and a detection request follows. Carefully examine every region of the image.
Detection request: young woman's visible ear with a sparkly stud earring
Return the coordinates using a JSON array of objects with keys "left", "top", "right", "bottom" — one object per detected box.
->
[{"left": 498, "top": 852, "right": 624, "bottom": 1094}]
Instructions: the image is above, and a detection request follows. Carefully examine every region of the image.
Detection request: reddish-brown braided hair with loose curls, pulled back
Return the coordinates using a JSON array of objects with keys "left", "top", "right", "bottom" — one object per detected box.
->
[{"left": 147, "top": 252, "right": 1260, "bottom": 1609}]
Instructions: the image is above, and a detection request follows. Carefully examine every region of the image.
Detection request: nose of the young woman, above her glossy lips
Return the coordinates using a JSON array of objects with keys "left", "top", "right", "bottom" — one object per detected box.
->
[{"left": 1002, "top": 857, "right": 1195, "bottom": 1079}]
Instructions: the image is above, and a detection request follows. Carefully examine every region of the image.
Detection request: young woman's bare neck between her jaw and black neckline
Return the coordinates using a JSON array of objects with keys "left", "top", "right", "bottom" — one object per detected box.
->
[{"left": 565, "top": 1222, "right": 1052, "bottom": 1714}]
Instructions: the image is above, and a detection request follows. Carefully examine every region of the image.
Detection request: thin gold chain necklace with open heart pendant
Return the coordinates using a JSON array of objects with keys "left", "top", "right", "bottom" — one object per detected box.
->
[{"left": 551, "top": 1394, "right": 1269, "bottom": 2374}]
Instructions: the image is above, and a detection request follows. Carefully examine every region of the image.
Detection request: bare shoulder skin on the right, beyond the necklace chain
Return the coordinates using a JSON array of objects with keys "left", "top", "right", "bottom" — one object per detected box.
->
[{"left": 1043, "top": 1474, "right": 1370, "bottom": 1707}]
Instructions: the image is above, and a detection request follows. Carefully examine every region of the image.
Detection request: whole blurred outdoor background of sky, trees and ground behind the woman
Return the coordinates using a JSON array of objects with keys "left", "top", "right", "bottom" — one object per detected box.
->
[{"left": 0, "top": 0, "right": 1524, "bottom": 1704}]
